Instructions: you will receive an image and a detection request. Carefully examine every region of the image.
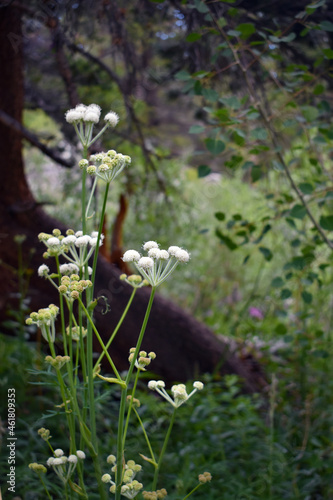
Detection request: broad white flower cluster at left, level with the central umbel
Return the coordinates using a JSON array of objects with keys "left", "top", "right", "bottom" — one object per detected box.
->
[{"left": 38, "top": 229, "right": 104, "bottom": 272}]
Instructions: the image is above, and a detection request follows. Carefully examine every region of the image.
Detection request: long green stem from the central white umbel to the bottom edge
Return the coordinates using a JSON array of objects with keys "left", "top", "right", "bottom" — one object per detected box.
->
[{"left": 115, "top": 287, "right": 156, "bottom": 500}]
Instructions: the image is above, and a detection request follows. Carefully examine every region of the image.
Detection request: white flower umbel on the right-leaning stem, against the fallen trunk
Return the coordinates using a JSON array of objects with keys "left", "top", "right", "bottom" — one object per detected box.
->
[{"left": 123, "top": 241, "right": 190, "bottom": 287}]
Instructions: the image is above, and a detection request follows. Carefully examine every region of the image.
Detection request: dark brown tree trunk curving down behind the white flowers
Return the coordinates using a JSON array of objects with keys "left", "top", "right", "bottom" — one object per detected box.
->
[{"left": 0, "top": 6, "right": 264, "bottom": 391}]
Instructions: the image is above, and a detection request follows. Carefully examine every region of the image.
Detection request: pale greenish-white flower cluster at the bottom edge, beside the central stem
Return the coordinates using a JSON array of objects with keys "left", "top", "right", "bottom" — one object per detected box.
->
[{"left": 102, "top": 455, "right": 143, "bottom": 498}]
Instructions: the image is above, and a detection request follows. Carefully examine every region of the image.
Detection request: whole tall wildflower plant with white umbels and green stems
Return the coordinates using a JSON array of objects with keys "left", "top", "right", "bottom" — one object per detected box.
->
[{"left": 26, "top": 104, "right": 207, "bottom": 500}]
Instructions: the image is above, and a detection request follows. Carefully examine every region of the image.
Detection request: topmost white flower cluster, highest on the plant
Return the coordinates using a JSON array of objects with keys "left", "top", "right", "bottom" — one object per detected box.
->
[{"left": 65, "top": 104, "right": 119, "bottom": 148}]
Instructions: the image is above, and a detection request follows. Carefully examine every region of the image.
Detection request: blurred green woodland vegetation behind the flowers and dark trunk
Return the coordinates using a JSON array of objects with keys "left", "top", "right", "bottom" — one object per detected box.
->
[{"left": 0, "top": 0, "right": 333, "bottom": 500}]
